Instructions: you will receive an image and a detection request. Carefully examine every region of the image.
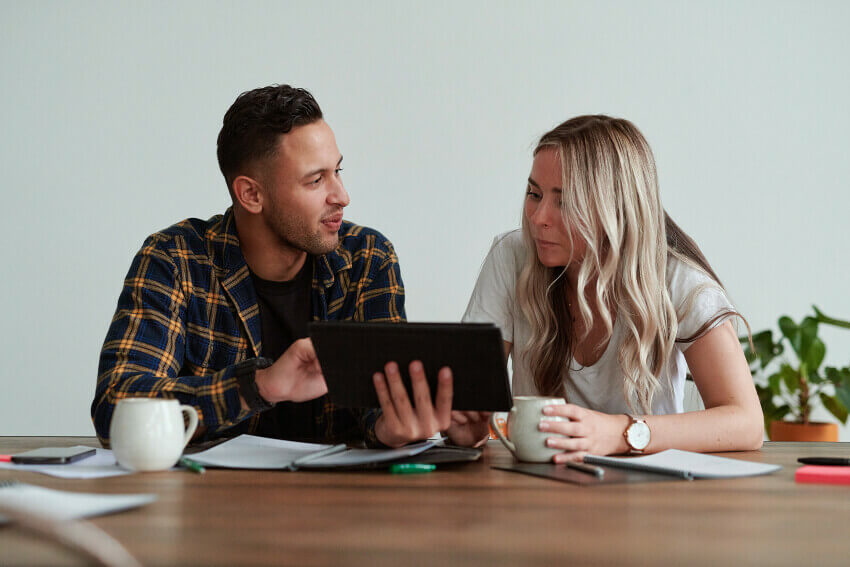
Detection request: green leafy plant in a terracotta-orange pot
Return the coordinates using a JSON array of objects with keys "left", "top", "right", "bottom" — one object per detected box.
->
[{"left": 741, "top": 306, "right": 850, "bottom": 441}]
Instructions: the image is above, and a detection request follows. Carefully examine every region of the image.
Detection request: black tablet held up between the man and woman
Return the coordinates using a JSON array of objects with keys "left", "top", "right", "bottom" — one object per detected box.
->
[{"left": 308, "top": 321, "right": 512, "bottom": 411}]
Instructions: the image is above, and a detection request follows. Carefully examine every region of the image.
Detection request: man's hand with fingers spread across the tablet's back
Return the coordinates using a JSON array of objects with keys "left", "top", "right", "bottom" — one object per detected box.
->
[{"left": 373, "top": 360, "right": 452, "bottom": 447}]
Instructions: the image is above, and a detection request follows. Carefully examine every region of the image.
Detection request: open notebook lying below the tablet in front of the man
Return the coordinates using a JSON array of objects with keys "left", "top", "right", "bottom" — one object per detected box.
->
[{"left": 190, "top": 434, "right": 481, "bottom": 471}]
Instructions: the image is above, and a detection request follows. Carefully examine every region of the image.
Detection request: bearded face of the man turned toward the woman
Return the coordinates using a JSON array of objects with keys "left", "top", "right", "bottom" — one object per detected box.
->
[{"left": 261, "top": 120, "right": 350, "bottom": 255}]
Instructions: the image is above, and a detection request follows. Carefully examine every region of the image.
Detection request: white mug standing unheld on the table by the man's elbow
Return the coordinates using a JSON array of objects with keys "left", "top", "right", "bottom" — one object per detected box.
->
[{"left": 109, "top": 398, "right": 198, "bottom": 471}]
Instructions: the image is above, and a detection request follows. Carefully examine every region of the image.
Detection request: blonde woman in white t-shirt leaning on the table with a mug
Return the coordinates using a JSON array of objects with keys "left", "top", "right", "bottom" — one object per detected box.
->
[{"left": 459, "top": 116, "right": 763, "bottom": 462}]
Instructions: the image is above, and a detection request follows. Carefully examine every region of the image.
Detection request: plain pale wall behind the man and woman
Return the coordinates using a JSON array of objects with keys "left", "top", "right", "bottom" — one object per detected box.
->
[{"left": 0, "top": 0, "right": 850, "bottom": 439}]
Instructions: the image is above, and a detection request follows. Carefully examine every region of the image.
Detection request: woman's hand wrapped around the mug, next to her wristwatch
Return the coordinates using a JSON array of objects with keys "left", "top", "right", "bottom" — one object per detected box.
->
[{"left": 539, "top": 404, "right": 631, "bottom": 463}]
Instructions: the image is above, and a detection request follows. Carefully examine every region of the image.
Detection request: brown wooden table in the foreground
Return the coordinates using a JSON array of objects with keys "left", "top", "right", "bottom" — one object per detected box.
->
[{"left": 0, "top": 437, "right": 850, "bottom": 566}]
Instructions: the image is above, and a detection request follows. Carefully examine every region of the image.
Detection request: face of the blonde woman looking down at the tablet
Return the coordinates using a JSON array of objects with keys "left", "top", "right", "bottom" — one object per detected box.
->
[{"left": 525, "top": 148, "right": 586, "bottom": 268}]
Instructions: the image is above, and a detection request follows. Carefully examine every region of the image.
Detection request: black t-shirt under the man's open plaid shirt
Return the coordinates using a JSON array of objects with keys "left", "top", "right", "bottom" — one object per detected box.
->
[{"left": 251, "top": 256, "right": 326, "bottom": 441}]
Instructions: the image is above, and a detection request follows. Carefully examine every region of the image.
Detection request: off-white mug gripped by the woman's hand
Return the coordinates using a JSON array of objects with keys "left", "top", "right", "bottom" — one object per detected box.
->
[{"left": 490, "top": 396, "right": 569, "bottom": 463}]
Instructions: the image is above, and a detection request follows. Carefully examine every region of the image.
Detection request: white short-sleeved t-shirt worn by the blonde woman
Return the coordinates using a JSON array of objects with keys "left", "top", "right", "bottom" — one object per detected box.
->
[{"left": 463, "top": 229, "right": 733, "bottom": 415}]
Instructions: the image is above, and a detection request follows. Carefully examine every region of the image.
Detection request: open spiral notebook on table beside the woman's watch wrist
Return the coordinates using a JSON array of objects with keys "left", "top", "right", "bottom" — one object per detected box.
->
[{"left": 584, "top": 449, "right": 782, "bottom": 480}]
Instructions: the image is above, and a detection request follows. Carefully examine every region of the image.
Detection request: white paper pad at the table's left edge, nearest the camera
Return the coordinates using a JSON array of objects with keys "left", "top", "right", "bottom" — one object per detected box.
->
[{"left": 0, "top": 482, "right": 156, "bottom": 524}]
